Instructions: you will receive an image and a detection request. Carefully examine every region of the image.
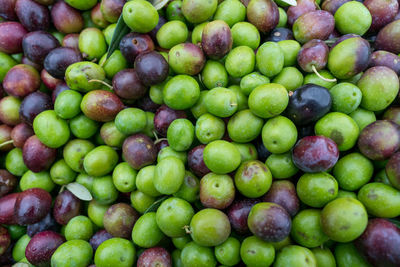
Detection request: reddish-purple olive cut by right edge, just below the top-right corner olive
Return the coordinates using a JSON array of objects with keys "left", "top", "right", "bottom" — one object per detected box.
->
[{"left": 375, "top": 20, "right": 400, "bottom": 55}]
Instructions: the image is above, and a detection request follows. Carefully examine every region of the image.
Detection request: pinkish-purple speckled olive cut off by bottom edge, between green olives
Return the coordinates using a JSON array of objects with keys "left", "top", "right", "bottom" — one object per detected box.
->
[{"left": 136, "top": 247, "right": 172, "bottom": 267}]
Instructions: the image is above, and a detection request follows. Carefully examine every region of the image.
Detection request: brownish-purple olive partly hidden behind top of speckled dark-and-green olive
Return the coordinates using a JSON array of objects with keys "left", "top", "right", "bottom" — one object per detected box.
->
[{"left": 262, "top": 180, "right": 300, "bottom": 217}]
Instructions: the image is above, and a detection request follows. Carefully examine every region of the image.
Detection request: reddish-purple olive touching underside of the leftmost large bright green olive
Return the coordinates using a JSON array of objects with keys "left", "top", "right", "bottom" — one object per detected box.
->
[{"left": 22, "top": 135, "right": 57, "bottom": 172}]
